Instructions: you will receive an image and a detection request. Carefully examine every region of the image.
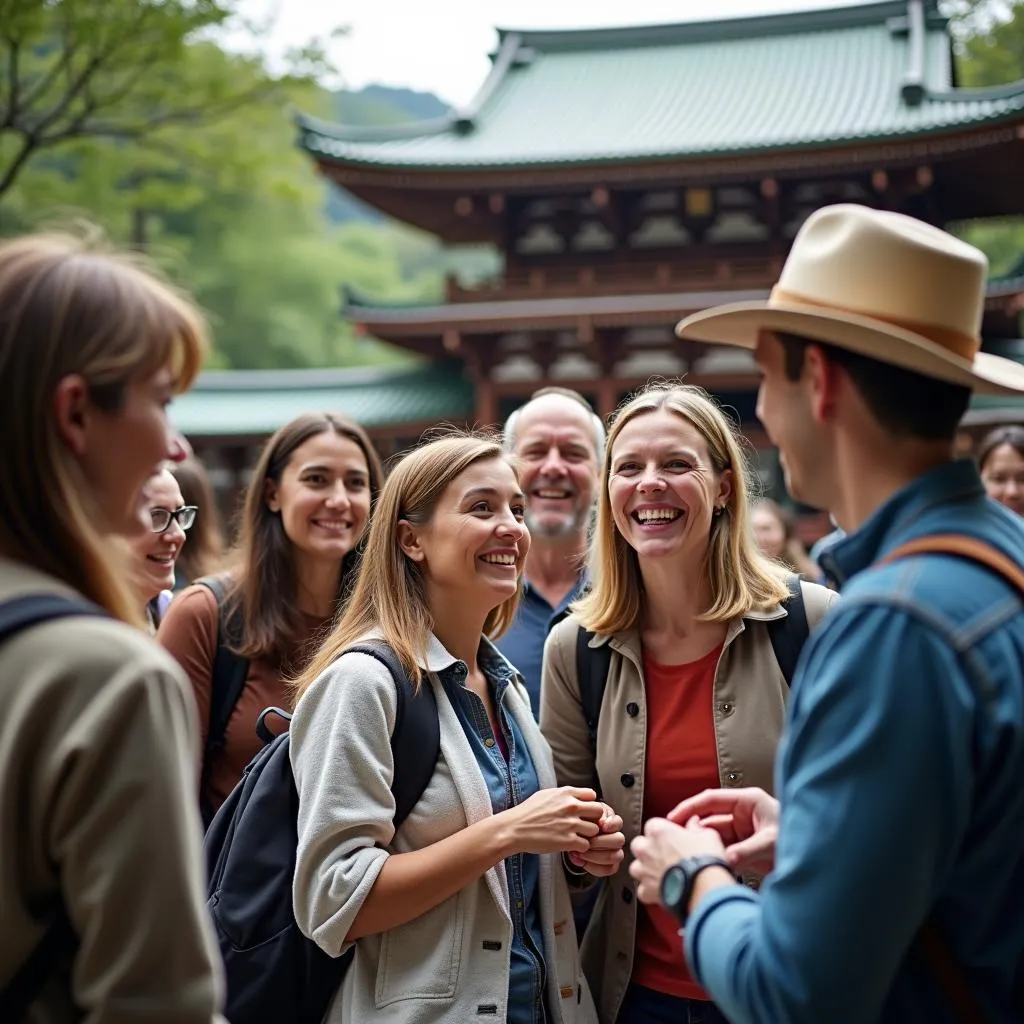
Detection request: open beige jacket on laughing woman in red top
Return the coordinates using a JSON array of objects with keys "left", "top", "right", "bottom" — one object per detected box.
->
[{"left": 541, "top": 583, "right": 839, "bottom": 1024}]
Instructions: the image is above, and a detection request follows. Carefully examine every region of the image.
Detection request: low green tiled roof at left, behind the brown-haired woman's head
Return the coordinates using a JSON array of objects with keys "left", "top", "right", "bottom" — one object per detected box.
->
[{"left": 171, "top": 366, "right": 473, "bottom": 437}]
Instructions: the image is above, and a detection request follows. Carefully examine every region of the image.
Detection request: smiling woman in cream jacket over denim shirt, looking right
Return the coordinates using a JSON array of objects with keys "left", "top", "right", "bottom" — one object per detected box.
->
[{"left": 291, "top": 434, "right": 624, "bottom": 1024}]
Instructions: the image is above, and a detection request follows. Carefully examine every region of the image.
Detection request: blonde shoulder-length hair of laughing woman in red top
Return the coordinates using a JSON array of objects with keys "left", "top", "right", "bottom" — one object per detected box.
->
[{"left": 572, "top": 382, "right": 788, "bottom": 635}]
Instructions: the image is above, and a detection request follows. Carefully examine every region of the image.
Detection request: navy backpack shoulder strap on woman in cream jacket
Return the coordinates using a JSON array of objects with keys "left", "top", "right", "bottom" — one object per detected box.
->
[{"left": 348, "top": 640, "right": 441, "bottom": 829}]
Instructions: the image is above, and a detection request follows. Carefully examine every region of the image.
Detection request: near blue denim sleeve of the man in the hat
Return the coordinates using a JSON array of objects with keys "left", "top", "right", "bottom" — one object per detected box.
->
[{"left": 686, "top": 603, "right": 975, "bottom": 1024}]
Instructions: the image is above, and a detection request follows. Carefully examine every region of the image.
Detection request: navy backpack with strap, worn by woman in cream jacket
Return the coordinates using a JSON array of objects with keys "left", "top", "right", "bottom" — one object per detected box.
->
[{"left": 203, "top": 641, "right": 440, "bottom": 1024}]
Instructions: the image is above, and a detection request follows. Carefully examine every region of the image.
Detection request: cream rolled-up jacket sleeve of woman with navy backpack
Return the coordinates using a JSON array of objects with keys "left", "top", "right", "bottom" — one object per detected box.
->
[{"left": 290, "top": 653, "right": 397, "bottom": 956}]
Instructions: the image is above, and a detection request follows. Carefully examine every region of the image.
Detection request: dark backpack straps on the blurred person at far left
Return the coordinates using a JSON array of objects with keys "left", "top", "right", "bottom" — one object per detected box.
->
[{"left": 0, "top": 594, "right": 106, "bottom": 1024}]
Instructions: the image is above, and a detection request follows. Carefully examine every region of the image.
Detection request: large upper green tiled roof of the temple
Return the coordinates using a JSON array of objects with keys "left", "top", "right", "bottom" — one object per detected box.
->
[{"left": 299, "top": 0, "right": 1024, "bottom": 170}]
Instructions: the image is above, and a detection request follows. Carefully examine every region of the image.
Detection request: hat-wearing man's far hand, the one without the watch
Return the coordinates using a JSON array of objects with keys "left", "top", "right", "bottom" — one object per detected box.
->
[{"left": 669, "top": 787, "right": 778, "bottom": 874}]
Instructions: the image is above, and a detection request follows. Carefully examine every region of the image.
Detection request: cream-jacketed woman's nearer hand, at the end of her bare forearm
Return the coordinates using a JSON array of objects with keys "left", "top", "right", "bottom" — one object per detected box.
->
[{"left": 495, "top": 785, "right": 606, "bottom": 855}]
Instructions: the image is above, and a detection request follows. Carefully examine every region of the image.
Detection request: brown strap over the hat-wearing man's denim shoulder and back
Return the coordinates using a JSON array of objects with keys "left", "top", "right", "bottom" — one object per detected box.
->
[{"left": 882, "top": 534, "right": 1024, "bottom": 1024}]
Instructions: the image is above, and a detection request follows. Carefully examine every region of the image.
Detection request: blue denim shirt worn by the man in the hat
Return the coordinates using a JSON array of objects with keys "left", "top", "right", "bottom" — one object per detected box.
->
[{"left": 686, "top": 462, "right": 1024, "bottom": 1024}]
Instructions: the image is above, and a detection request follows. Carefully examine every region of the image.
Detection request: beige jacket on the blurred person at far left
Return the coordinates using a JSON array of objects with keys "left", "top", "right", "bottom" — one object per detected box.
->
[{"left": 0, "top": 558, "right": 221, "bottom": 1024}]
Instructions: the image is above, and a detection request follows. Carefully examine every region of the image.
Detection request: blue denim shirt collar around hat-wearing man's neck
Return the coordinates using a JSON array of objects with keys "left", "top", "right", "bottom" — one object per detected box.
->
[{"left": 821, "top": 459, "right": 985, "bottom": 584}]
